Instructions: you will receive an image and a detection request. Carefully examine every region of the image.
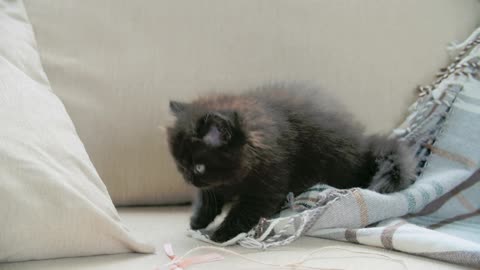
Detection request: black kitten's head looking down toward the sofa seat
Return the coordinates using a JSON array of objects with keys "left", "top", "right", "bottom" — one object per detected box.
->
[{"left": 167, "top": 101, "right": 248, "bottom": 188}]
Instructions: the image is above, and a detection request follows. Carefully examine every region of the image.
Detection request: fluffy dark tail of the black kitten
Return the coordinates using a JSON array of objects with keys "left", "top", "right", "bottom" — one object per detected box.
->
[{"left": 367, "top": 135, "right": 415, "bottom": 193}]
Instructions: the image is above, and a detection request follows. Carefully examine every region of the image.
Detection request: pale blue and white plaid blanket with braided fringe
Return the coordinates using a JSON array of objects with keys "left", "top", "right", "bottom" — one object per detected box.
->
[{"left": 191, "top": 28, "right": 480, "bottom": 268}]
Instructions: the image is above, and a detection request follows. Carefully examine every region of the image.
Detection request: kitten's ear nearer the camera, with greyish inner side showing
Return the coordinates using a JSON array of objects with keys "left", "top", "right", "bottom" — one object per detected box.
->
[{"left": 202, "top": 112, "right": 238, "bottom": 147}]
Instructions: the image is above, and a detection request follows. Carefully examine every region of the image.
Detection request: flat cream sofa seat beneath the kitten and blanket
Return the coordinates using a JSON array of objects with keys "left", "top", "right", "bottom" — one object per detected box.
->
[{"left": 0, "top": 206, "right": 470, "bottom": 270}]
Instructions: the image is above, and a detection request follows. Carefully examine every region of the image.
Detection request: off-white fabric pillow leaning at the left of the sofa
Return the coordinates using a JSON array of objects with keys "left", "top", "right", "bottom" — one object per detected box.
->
[{"left": 0, "top": 0, "right": 153, "bottom": 262}]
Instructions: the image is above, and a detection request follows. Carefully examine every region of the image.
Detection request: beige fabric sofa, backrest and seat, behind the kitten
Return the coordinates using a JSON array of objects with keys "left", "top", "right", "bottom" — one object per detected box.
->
[{"left": 0, "top": 0, "right": 480, "bottom": 270}]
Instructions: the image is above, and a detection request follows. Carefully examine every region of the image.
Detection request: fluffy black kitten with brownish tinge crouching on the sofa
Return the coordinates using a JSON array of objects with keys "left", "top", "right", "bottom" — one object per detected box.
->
[{"left": 168, "top": 85, "right": 414, "bottom": 242}]
